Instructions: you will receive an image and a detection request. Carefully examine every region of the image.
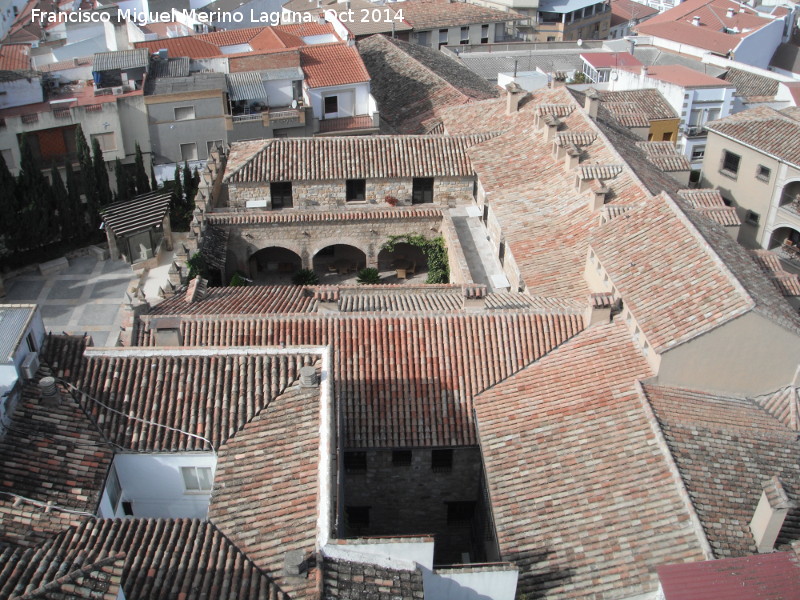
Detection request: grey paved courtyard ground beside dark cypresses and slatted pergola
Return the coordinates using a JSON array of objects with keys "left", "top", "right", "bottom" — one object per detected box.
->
[{"left": 0, "top": 256, "right": 134, "bottom": 346}]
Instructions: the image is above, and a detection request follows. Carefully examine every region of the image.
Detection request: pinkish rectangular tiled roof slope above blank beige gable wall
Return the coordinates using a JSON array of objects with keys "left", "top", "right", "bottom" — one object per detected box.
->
[{"left": 590, "top": 195, "right": 754, "bottom": 352}]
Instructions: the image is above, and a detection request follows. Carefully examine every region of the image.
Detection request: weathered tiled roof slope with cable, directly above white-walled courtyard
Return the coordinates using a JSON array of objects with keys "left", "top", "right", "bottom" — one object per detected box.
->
[{"left": 75, "top": 349, "right": 310, "bottom": 452}]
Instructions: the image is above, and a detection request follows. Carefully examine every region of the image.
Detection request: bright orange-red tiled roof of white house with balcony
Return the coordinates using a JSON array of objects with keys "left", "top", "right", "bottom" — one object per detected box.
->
[{"left": 300, "top": 43, "right": 369, "bottom": 88}]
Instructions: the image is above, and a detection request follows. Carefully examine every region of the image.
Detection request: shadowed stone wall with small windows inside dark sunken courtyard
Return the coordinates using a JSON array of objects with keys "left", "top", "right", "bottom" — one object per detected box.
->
[{"left": 344, "top": 447, "right": 482, "bottom": 564}]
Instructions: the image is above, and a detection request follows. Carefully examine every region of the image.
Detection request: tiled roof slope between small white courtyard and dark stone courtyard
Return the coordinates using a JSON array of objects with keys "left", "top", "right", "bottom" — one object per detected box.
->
[{"left": 208, "top": 376, "right": 324, "bottom": 598}]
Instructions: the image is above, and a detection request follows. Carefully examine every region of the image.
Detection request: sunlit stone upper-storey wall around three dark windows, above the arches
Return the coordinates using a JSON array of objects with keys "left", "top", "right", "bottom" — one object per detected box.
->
[{"left": 228, "top": 177, "right": 474, "bottom": 210}]
